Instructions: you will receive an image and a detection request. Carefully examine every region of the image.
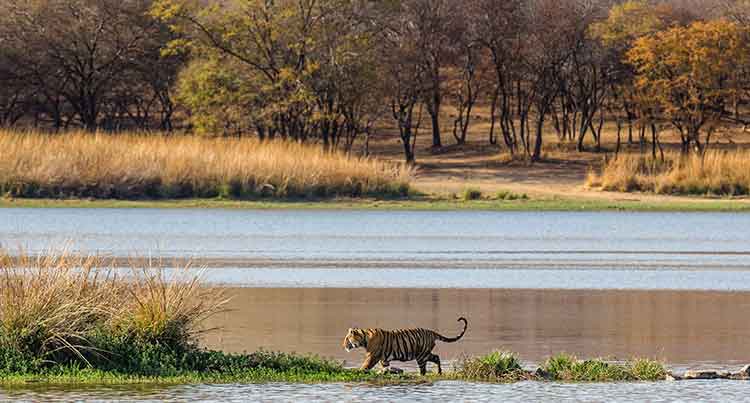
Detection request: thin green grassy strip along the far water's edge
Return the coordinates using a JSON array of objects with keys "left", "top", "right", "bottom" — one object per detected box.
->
[{"left": 0, "top": 195, "right": 750, "bottom": 212}]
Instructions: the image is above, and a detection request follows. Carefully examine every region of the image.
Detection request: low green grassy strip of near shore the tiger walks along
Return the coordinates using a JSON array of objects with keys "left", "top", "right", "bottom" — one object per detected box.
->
[{"left": 0, "top": 352, "right": 750, "bottom": 390}]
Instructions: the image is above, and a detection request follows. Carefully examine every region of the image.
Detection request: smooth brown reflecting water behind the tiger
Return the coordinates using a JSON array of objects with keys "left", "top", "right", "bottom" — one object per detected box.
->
[{"left": 206, "top": 289, "right": 750, "bottom": 367}]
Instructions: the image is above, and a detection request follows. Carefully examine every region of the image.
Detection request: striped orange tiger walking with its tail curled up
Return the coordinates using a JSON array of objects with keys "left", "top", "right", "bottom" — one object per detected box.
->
[{"left": 343, "top": 317, "right": 469, "bottom": 375}]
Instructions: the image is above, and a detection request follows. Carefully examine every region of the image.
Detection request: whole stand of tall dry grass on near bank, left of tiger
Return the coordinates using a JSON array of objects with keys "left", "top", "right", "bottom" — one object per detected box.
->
[{"left": 0, "top": 251, "right": 226, "bottom": 369}]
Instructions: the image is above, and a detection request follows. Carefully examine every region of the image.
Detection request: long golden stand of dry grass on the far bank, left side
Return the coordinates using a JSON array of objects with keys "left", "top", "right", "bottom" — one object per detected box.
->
[{"left": 0, "top": 130, "right": 411, "bottom": 199}]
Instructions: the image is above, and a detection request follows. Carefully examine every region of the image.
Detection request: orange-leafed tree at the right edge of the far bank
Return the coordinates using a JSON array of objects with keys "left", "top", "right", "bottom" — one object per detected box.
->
[{"left": 627, "top": 20, "right": 748, "bottom": 153}]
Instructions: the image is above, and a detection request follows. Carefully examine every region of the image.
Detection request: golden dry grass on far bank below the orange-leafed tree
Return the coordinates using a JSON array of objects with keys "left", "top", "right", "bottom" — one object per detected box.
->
[{"left": 587, "top": 151, "right": 750, "bottom": 196}]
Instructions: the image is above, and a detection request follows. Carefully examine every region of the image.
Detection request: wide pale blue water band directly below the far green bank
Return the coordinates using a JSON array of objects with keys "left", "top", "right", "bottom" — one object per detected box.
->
[{"left": 0, "top": 209, "right": 750, "bottom": 269}]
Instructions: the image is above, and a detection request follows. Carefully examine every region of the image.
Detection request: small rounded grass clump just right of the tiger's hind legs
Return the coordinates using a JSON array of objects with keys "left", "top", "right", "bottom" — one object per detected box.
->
[{"left": 456, "top": 351, "right": 528, "bottom": 382}]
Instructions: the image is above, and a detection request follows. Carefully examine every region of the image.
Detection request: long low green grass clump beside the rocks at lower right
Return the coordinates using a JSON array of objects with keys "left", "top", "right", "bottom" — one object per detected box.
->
[{"left": 538, "top": 353, "right": 666, "bottom": 382}]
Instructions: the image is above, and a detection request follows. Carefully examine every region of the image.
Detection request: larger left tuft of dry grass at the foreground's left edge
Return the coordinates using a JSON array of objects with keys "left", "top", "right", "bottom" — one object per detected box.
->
[{"left": 0, "top": 253, "right": 122, "bottom": 359}]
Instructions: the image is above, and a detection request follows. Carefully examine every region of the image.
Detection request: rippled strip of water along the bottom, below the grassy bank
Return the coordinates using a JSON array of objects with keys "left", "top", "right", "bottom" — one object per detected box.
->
[{"left": 0, "top": 381, "right": 749, "bottom": 402}]
